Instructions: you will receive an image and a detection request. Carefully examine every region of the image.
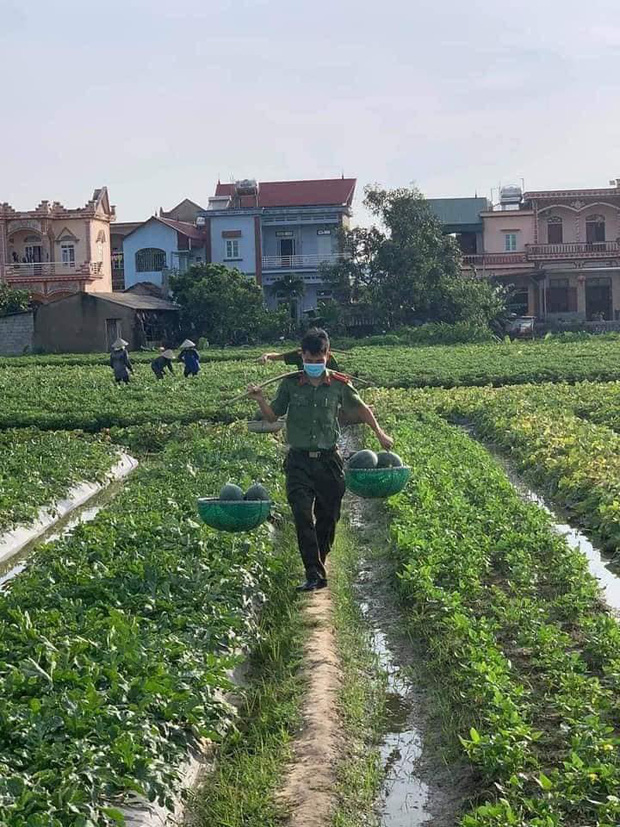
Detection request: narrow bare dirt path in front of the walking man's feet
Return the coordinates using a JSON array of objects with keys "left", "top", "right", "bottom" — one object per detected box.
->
[{"left": 279, "top": 589, "right": 343, "bottom": 827}]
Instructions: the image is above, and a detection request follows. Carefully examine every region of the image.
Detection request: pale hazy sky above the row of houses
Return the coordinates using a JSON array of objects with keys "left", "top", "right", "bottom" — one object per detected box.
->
[{"left": 0, "top": 0, "right": 620, "bottom": 223}]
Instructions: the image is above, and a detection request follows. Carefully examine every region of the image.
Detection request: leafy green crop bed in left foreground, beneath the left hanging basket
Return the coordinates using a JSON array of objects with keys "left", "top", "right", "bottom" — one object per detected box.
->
[{"left": 0, "top": 425, "right": 284, "bottom": 827}]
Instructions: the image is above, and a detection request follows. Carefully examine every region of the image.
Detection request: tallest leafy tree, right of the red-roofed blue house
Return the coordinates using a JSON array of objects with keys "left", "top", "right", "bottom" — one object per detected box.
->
[{"left": 326, "top": 187, "right": 504, "bottom": 330}]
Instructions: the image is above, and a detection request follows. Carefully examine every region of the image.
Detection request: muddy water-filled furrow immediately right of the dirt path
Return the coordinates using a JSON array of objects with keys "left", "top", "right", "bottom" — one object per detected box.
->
[{"left": 346, "top": 497, "right": 473, "bottom": 827}]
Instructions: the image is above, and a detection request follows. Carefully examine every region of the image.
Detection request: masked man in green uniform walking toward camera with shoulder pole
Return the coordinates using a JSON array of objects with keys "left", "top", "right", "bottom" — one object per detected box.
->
[{"left": 248, "top": 328, "right": 394, "bottom": 591}]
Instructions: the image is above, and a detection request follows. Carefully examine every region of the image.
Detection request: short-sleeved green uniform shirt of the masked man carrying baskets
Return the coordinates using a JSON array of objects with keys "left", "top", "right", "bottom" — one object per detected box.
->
[{"left": 271, "top": 370, "right": 364, "bottom": 451}]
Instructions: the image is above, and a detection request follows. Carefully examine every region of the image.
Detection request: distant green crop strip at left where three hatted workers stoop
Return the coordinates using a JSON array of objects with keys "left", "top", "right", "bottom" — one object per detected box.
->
[{"left": 0, "top": 361, "right": 289, "bottom": 431}]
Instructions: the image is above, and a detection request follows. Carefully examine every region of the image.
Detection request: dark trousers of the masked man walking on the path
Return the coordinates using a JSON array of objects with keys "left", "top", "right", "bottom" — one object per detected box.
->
[{"left": 284, "top": 448, "right": 345, "bottom": 580}]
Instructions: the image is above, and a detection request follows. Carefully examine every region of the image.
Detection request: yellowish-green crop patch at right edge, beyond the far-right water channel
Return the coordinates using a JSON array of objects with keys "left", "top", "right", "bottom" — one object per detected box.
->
[{"left": 372, "top": 383, "right": 620, "bottom": 553}]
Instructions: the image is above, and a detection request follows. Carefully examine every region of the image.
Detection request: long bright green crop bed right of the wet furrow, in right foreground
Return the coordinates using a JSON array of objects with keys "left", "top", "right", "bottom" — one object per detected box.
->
[{"left": 380, "top": 414, "right": 620, "bottom": 827}]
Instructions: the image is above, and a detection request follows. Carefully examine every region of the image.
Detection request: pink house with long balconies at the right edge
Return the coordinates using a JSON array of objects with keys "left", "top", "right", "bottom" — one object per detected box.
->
[{"left": 431, "top": 179, "right": 620, "bottom": 321}]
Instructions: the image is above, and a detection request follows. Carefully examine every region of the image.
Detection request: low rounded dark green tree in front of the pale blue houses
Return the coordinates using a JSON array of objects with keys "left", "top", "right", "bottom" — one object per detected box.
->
[{"left": 170, "top": 264, "right": 290, "bottom": 344}]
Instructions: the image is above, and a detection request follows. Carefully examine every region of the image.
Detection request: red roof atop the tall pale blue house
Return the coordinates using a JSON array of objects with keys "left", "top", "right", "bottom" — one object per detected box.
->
[{"left": 215, "top": 178, "right": 357, "bottom": 207}]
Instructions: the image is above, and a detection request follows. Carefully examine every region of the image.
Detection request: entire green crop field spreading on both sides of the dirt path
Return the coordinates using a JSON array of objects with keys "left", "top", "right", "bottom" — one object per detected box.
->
[{"left": 0, "top": 339, "right": 620, "bottom": 827}]
